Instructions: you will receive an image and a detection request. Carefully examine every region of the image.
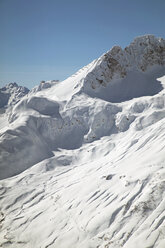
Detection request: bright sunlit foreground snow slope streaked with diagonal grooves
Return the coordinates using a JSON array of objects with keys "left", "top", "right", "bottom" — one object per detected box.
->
[{"left": 0, "top": 113, "right": 165, "bottom": 248}]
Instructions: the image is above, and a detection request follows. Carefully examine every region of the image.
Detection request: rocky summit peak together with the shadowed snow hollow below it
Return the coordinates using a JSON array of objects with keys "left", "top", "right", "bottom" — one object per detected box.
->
[{"left": 79, "top": 35, "right": 165, "bottom": 102}]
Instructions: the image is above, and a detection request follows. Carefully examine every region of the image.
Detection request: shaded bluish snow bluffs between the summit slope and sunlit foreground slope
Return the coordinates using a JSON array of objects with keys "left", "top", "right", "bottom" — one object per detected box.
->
[{"left": 0, "top": 93, "right": 121, "bottom": 179}]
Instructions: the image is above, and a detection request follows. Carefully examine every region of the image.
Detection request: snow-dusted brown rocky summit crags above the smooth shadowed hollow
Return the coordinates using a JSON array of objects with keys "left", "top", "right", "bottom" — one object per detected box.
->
[{"left": 83, "top": 35, "right": 165, "bottom": 97}]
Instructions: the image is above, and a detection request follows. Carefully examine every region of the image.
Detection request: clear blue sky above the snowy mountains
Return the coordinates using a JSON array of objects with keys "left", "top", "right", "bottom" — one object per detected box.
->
[{"left": 0, "top": 0, "right": 165, "bottom": 88}]
